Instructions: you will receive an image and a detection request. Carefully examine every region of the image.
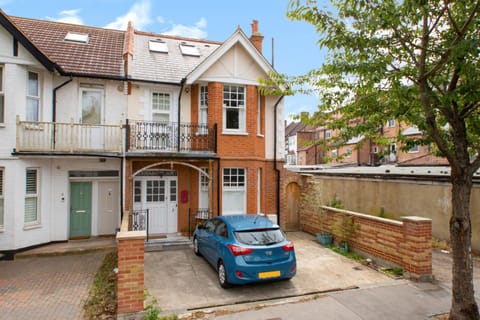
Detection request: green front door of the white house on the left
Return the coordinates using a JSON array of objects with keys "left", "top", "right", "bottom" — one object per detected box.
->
[{"left": 70, "top": 182, "right": 92, "bottom": 238}]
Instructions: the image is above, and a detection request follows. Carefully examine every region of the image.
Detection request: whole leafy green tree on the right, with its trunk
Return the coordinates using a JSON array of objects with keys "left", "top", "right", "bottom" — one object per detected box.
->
[{"left": 276, "top": 0, "right": 480, "bottom": 319}]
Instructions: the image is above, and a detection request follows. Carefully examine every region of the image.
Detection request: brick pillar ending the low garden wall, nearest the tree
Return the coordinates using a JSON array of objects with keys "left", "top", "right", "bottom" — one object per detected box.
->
[{"left": 402, "top": 217, "right": 432, "bottom": 281}]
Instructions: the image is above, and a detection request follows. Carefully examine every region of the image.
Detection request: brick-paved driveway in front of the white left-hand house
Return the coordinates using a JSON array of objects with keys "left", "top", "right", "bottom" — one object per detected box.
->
[{"left": 0, "top": 252, "right": 105, "bottom": 320}]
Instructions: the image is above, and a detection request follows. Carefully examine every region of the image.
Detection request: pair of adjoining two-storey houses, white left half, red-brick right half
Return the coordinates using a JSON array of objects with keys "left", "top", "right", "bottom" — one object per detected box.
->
[{"left": 0, "top": 10, "right": 284, "bottom": 252}]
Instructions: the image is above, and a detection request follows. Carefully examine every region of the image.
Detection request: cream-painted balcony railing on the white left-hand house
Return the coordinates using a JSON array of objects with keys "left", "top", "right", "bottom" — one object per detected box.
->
[{"left": 16, "top": 116, "right": 124, "bottom": 154}]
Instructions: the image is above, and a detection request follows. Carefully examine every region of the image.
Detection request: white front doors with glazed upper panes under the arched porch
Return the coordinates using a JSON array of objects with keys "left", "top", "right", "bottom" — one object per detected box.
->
[{"left": 133, "top": 171, "right": 178, "bottom": 234}]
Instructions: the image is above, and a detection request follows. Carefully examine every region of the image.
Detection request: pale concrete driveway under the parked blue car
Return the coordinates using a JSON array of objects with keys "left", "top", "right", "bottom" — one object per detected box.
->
[{"left": 145, "top": 232, "right": 395, "bottom": 311}]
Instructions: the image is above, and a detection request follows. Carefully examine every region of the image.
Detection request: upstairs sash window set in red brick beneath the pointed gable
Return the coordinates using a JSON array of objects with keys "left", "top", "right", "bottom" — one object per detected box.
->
[{"left": 223, "top": 85, "right": 246, "bottom": 132}]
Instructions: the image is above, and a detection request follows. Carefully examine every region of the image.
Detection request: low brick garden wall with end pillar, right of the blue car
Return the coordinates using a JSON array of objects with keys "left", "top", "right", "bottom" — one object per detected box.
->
[{"left": 300, "top": 204, "right": 432, "bottom": 281}]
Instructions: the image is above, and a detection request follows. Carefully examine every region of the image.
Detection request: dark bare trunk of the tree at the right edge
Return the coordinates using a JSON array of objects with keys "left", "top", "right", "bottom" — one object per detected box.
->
[{"left": 449, "top": 166, "right": 480, "bottom": 320}]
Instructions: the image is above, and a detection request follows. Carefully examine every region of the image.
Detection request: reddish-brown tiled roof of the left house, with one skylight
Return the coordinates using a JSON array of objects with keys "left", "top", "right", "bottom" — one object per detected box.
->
[{"left": 9, "top": 16, "right": 125, "bottom": 78}]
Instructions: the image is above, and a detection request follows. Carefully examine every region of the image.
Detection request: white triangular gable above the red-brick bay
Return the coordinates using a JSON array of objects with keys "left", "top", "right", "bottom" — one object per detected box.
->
[{"left": 199, "top": 43, "right": 267, "bottom": 85}]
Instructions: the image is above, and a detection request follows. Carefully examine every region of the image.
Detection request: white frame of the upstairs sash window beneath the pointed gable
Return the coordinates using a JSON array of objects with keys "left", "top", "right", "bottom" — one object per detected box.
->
[{"left": 222, "top": 84, "right": 247, "bottom": 133}]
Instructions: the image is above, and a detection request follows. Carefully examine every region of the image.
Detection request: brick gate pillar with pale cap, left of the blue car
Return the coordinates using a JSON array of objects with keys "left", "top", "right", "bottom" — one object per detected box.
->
[{"left": 117, "top": 231, "right": 146, "bottom": 315}]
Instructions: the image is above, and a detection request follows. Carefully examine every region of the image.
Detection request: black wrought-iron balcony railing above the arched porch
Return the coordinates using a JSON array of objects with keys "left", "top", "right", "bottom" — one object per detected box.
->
[{"left": 127, "top": 121, "right": 217, "bottom": 152}]
